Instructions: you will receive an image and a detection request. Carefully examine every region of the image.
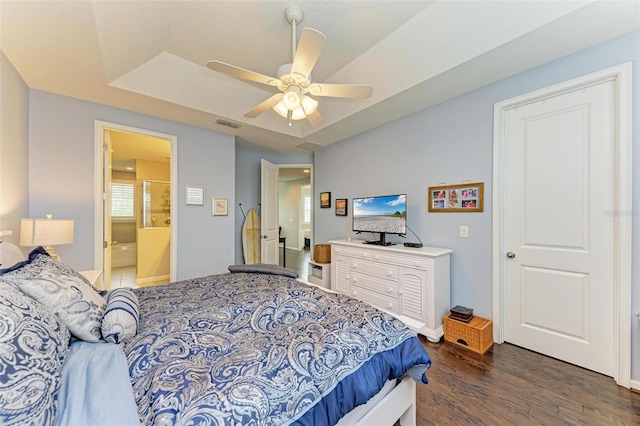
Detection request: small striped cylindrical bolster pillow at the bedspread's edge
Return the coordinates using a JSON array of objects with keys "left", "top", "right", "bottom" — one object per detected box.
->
[{"left": 102, "top": 288, "right": 140, "bottom": 343}]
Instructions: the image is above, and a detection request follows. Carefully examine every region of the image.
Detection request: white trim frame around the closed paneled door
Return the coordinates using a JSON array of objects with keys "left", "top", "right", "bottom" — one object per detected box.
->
[{"left": 492, "top": 62, "right": 632, "bottom": 388}]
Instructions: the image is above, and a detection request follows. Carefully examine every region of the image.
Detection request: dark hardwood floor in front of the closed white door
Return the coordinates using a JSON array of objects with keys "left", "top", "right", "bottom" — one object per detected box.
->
[{"left": 416, "top": 336, "right": 640, "bottom": 425}]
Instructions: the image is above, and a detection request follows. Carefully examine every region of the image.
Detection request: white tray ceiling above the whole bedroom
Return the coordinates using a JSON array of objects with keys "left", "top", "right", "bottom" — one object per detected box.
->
[{"left": 0, "top": 0, "right": 640, "bottom": 153}]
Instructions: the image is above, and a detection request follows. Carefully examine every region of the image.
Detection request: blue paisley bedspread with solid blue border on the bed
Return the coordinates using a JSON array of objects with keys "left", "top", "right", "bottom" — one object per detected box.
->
[{"left": 125, "top": 273, "right": 431, "bottom": 425}]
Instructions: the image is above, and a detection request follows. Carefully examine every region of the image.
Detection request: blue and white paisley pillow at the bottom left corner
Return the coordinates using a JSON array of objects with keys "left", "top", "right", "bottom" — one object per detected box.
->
[{"left": 0, "top": 279, "right": 71, "bottom": 425}]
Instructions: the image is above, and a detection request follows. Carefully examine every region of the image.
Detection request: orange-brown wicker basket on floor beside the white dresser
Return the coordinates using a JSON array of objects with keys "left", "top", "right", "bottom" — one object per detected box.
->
[{"left": 444, "top": 315, "right": 493, "bottom": 354}]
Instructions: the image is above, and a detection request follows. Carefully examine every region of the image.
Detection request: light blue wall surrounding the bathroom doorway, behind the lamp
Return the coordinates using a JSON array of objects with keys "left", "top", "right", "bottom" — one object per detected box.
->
[{"left": 29, "top": 90, "right": 235, "bottom": 279}]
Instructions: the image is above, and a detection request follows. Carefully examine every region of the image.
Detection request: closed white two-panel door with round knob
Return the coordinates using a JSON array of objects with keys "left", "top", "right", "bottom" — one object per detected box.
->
[{"left": 503, "top": 80, "right": 616, "bottom": 376}]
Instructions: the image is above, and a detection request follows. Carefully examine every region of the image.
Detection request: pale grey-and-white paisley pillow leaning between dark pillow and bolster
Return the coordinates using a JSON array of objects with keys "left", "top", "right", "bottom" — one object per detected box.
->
[{"left": 2, "top": 248, "right": 106, "bottom": 342}]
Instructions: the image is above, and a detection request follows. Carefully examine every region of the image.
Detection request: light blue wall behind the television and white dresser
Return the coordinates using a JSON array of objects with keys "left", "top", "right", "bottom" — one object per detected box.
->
[{"left": 314, "top": 32, "right": 640, "bottom": 378}]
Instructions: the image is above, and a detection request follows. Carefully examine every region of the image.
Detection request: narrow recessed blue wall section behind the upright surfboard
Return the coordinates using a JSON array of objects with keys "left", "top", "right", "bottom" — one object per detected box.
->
[{"left": 236, "top": 141, "right": 313, "bottom": 263}]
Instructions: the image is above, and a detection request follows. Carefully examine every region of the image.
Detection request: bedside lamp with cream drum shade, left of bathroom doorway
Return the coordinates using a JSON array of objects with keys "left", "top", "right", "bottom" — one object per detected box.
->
[{"left": 20, "top": 214, "right": 73, "bottom": 261}]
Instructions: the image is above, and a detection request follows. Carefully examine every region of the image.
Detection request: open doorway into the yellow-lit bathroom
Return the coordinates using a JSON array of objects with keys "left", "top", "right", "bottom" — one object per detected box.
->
[{"left": 94, "top": 122, "right": 176, "bottom": 288}]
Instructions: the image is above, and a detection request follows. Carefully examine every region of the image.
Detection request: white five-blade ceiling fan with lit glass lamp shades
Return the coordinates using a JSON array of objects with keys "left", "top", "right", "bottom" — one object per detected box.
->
[{"left": 207, "top": 6, "right": 373, "bottom": 126}]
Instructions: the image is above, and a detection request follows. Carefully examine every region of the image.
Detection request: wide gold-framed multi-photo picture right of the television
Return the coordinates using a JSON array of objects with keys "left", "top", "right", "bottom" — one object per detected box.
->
[{"left": 429, "top": 182, "right": 484, "bottom": 212}]
